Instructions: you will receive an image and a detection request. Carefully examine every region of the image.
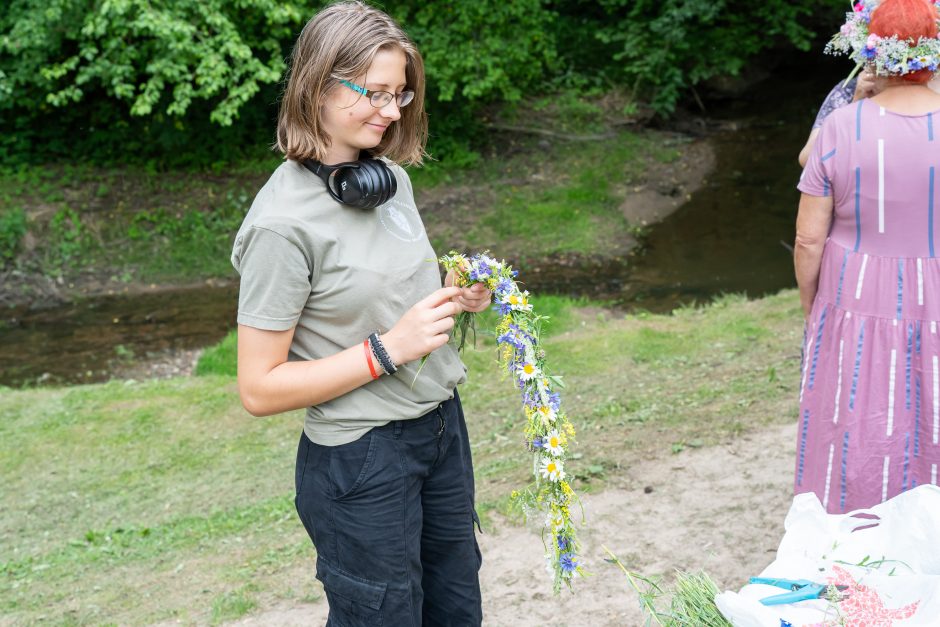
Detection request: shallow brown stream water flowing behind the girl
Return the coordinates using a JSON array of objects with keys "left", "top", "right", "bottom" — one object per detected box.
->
[{"left": 0, "top": 61, "right": 845, "bottom": 385}]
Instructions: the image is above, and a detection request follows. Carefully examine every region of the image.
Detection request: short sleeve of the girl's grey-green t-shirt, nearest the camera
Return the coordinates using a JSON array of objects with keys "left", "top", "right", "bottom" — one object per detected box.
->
[{"left": 232, "top": 226, "right": 312, "bottom": 331}]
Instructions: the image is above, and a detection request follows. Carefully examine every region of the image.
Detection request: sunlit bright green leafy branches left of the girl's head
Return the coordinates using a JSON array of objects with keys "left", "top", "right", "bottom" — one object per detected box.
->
[{"left": 0, "top": 0, "right": 304, "bottom": 126}]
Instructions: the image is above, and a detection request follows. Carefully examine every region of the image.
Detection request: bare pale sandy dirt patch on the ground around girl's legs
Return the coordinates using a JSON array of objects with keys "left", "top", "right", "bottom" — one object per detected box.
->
[{"left": 233, "top": 423, "right": 796, "bottom": 627}]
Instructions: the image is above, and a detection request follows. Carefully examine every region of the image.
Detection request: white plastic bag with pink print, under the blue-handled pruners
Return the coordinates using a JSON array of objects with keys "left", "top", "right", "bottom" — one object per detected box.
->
[{"left": 715, "top": 485, "right": 940, "bottom": 627}]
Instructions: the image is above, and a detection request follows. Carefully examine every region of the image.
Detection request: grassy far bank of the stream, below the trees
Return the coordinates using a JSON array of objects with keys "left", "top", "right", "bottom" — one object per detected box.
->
[{"left": 0, "top": 129, "right": 715, "bottom": 318}]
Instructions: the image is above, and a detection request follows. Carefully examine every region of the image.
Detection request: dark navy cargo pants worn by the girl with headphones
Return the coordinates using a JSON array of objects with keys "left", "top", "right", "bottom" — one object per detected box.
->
[{"left": 295, "top": 391, "right": 482, "bottom": 627}]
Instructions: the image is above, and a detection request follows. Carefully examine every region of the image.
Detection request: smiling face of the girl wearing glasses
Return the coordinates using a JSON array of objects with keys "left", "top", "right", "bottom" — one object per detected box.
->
[{"left": 322, "top": 48, "right": 407, "bottom": 165}]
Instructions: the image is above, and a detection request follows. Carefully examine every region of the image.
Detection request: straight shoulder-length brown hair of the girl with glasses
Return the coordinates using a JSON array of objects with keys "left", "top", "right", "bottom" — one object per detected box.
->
[{"left": 276, "top": 2, "right": 428, "bottom": 165}]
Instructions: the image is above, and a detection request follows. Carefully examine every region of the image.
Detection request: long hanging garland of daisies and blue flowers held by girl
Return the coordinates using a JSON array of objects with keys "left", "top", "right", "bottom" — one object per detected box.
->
[{"left": 439, "top": 252, "right": 584, "bottom": 593}]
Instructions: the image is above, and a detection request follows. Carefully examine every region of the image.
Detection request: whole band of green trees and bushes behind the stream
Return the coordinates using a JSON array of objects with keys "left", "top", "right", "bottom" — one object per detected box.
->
[{"left": 0, "top": 0, "right": 843, "bottom": 168}]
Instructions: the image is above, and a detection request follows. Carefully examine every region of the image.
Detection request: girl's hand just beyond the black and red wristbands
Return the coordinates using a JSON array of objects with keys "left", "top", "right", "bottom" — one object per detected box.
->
[{"left": 380, "top": 287, "right": 463, "bottom": 366}]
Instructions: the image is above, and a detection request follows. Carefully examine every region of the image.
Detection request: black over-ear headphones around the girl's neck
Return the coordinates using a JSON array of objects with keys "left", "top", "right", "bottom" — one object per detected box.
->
[{"left": 304, "top": 158, "right": 398, "bottom": 209}]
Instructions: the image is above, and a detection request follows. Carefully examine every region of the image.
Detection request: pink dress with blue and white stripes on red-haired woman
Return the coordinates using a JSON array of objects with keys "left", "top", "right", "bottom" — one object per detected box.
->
[{"left": 794, "top": 100, "right": 940, "bottom": 513}]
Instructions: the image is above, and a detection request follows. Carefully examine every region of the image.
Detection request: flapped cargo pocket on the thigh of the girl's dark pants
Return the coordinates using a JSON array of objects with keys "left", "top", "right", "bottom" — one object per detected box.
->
[{"left": 317, "top": 557, "right": 388, "bottom": 627}]
